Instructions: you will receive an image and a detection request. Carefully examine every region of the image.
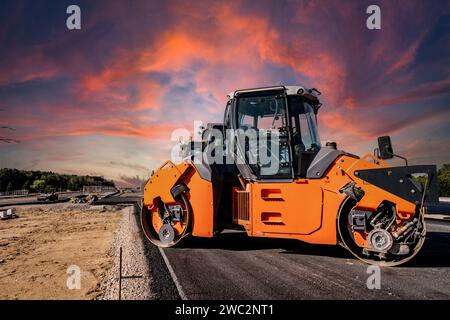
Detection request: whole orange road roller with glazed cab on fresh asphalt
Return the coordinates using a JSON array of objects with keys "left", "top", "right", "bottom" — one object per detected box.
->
[{"left": 141, "top": 86, "right": 438, "bottom": 266}]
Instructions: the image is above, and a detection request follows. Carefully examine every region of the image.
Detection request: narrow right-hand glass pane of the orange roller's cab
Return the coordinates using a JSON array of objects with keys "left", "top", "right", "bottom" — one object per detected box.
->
[{"left": 288, "top": 96, "right": 320, "bottom": 152}]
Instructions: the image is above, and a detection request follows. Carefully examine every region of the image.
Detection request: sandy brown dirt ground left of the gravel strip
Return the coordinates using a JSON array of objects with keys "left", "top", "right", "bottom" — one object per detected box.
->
[{"left": 0, "top": 204, "right": 122, "bottom": 299}]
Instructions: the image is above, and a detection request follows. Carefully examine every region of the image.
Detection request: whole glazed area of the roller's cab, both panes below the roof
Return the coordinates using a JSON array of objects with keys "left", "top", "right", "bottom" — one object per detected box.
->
[{"left": 235, "top": 92, "right": 320, "bottom": 178}]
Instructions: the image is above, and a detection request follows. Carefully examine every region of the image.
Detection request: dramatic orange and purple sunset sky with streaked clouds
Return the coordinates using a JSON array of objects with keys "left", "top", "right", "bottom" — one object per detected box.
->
[{"left": 0, "top": 0, "right": 450, "bottom": 184}]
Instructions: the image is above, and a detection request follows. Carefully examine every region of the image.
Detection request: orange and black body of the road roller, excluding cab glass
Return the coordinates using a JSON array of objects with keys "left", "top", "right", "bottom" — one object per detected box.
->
[{"left": 141, "top": 86, "right": 437, "bottom": 265}]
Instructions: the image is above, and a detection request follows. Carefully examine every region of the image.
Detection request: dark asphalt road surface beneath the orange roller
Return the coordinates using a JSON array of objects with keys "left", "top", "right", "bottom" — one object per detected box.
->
[{"left": 164, "top": 221, "right": 450, "bottom": 300}]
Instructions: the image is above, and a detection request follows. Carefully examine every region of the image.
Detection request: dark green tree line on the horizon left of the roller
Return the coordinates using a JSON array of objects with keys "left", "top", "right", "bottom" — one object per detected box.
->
[{"left": 0, "top": 168, "right": 115, "bottom": 193}]
